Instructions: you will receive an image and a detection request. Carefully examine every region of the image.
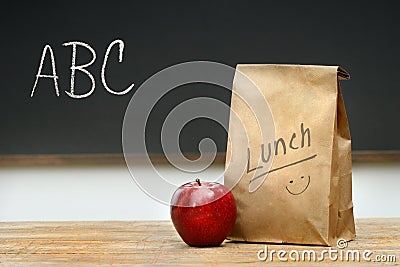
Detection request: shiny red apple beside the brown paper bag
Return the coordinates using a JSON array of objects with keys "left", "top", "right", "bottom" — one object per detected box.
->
[{"left": 171, "top": 179, "right": 236, "bottom": 247}]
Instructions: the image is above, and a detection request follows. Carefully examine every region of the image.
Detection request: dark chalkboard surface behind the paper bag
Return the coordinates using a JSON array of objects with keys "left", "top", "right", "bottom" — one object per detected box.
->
[{"left": 0, "top": 0, "right": 400, "bottom": 155}]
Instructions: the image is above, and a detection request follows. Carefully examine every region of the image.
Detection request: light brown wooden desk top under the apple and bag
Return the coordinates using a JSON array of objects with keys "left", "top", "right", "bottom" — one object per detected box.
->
[{"left": 0, "top": 218, "right": 400, "bottom": 266}]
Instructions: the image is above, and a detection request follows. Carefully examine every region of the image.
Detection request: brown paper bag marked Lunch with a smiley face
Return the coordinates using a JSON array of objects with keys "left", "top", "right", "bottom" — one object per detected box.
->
[{"left": 224, "top": 64, "right": 355, "bottom": 246}]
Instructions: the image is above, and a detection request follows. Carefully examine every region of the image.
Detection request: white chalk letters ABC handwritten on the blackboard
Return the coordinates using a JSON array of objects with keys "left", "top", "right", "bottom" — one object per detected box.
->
[{"left": 31, "top": 39, "right": 134, "bottom": 98}]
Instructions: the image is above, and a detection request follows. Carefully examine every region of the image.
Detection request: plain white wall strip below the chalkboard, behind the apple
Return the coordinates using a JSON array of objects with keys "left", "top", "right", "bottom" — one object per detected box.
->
[{"left": 0, "top": 163, "right": 400, "bottom": 221}]
